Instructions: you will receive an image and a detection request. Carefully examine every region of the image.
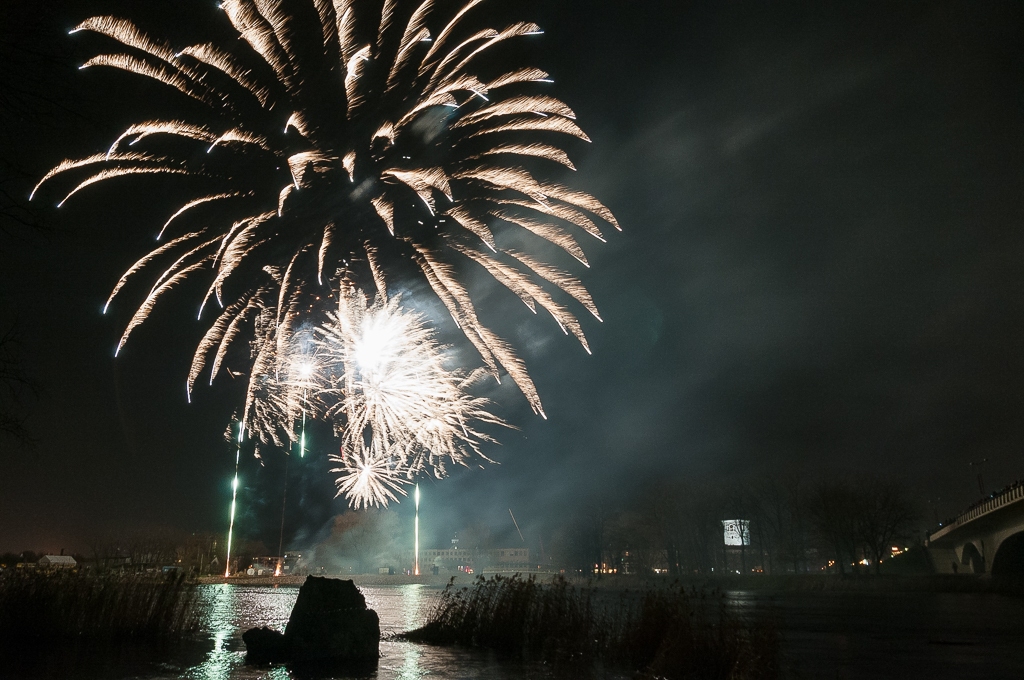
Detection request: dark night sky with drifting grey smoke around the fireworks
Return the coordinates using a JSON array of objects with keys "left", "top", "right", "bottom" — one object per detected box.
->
[{"left": 0, "top": 0, "right": 1024, "bottom": 551}]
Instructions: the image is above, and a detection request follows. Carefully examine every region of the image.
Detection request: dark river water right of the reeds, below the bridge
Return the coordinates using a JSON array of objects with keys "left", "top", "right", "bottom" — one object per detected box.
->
[{"left": 727, "top": 591, "right": 1024, "bottom": 680}]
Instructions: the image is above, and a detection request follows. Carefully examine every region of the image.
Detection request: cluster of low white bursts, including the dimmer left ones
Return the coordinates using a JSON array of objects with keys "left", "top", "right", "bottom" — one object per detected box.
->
[{"left": 229, "top": 280, "right": 506, "bottom": 507}]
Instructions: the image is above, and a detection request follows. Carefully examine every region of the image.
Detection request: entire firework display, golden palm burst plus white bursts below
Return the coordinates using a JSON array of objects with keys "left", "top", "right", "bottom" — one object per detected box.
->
[{"left": 33, "top": 0, "right": 618, "bottom": 505}]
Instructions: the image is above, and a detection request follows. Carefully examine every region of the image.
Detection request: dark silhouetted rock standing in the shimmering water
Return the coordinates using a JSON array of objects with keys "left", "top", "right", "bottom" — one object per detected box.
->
[{"left": 242, "top": 577, "right": 381, "bottom": 664}]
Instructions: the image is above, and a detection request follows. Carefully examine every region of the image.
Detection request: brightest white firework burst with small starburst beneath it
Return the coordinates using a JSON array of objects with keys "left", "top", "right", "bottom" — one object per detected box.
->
[{"left": 316, "top": 291, "right": 504, "bottom": 504}]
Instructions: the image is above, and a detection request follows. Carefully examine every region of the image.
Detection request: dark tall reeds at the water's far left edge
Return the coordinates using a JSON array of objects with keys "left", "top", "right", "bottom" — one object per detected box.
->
[{"left": 0, "top": 571, "right": 199, "bottom": 645}]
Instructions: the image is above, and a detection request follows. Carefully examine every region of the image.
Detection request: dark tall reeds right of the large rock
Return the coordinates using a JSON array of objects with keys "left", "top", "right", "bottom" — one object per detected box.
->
[{"left": 402, "top": 576, "right": 780, "bottom": 680}]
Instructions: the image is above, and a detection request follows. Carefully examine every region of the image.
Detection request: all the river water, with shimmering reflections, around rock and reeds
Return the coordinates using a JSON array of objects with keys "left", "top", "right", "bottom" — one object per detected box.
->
[{"left": 0, "top": 584, "right": 1024, "bottom": 680}]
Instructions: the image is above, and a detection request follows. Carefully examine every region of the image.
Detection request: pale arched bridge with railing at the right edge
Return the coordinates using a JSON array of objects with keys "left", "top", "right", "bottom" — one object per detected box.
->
[{"left": 927, "top": 482, "right": 1024, "bottom": 576}]
